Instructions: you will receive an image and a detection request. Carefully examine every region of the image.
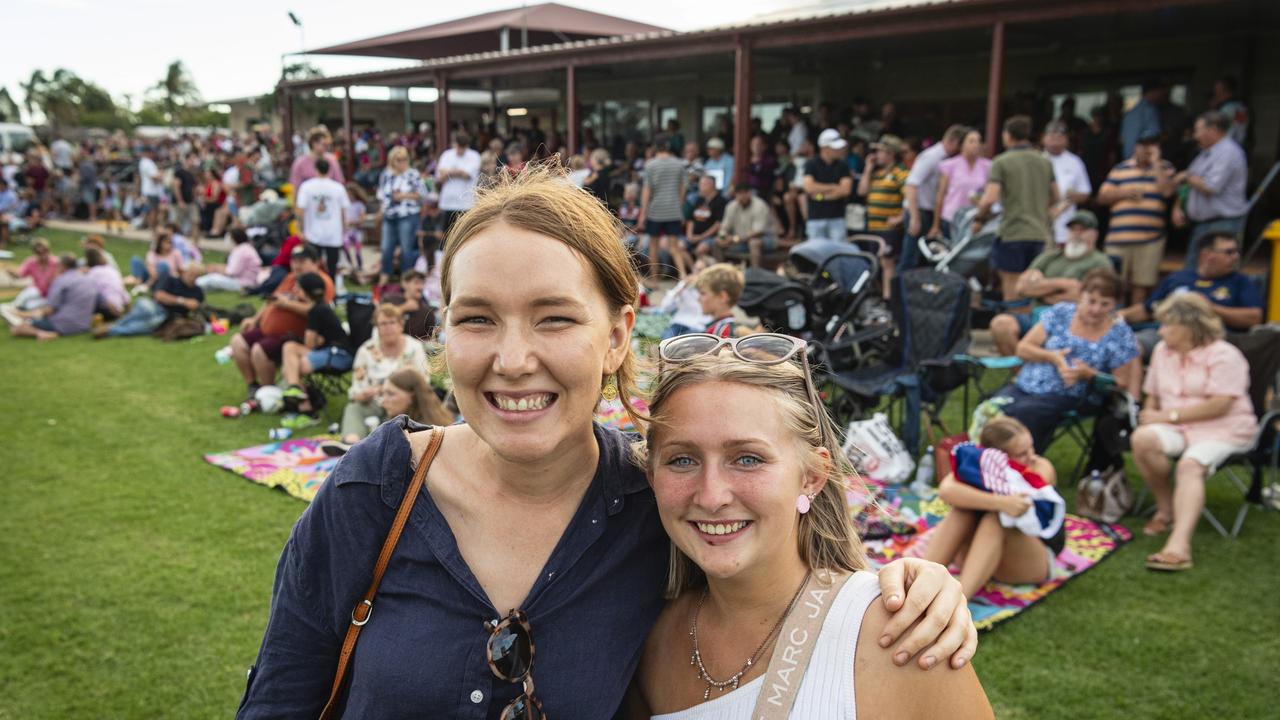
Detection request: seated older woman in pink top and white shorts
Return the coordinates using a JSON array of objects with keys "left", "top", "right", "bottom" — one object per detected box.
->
[{"left": 1130, "top": 292, "right": 1258, "bottom": 570}]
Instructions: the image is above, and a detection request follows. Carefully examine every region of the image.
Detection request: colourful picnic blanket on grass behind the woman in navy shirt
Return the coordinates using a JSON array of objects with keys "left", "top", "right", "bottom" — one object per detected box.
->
[{"left": 205, "top": 397, "right": 648, "bottom": 502}]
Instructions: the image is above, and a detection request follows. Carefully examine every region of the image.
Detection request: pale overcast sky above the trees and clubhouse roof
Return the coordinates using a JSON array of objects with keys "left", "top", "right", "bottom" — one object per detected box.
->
[{"left": 0, "top": 0, "right": 798, "bottom": 117}]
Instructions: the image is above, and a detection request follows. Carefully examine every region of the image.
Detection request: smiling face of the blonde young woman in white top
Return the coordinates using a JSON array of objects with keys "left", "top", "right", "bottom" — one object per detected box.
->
[{"left": 649, "top": 380, "right": 822, "bottom": 578}]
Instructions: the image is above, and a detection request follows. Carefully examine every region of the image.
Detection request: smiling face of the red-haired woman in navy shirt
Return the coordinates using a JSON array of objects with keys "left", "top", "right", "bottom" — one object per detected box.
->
[{"left": 445, "top": 222, "right": 635, "bottom": 461}]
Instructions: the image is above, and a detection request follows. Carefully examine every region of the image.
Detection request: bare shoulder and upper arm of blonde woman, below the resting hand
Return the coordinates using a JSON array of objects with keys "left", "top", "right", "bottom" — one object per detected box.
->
[{"left": 854, "top": 601, "right": 995, "bottom": 720}]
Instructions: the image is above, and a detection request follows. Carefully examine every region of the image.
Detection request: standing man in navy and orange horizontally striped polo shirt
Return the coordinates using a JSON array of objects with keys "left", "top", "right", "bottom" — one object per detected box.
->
[{"left": 1098, "top": 135, "right": 1174, "bottom": 304}]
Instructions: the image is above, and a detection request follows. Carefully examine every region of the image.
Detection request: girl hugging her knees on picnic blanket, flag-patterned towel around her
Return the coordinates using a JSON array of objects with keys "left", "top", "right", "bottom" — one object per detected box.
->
[{"left": 924, "top": 415, "right": 1066, "bottom": 598}]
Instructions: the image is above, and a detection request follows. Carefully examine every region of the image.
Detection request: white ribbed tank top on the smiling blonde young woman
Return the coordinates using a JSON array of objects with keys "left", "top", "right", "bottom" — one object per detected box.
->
[{"left": 652, "top": 570, "right": 879, "bottom": 720}]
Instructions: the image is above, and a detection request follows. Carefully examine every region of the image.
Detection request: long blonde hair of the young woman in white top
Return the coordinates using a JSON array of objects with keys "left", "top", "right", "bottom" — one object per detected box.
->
[{"left": 645, "top": 352, "right": 867, "bottom": 600}]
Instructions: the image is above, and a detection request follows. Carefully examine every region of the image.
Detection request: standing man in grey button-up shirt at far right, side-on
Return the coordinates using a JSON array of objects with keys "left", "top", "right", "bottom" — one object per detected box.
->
[{"left": 1174, "top": 110, "right": 1249, "bottom": 270}]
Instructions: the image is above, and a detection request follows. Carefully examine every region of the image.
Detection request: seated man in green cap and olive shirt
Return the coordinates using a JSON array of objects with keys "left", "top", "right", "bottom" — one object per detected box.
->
[{"left": 991, "top": 210, "right": 1111, "bottom": 355}]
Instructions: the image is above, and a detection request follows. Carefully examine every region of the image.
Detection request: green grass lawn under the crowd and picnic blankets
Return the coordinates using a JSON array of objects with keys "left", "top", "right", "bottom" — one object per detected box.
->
[{"left": 0, "top": 226, "right": 1280, "bottom": 719}]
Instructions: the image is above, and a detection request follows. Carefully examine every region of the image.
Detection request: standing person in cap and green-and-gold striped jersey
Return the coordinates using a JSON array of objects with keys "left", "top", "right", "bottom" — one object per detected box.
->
[{"left": 858, "top": 135, "right": 909, "bottom": 300}]
